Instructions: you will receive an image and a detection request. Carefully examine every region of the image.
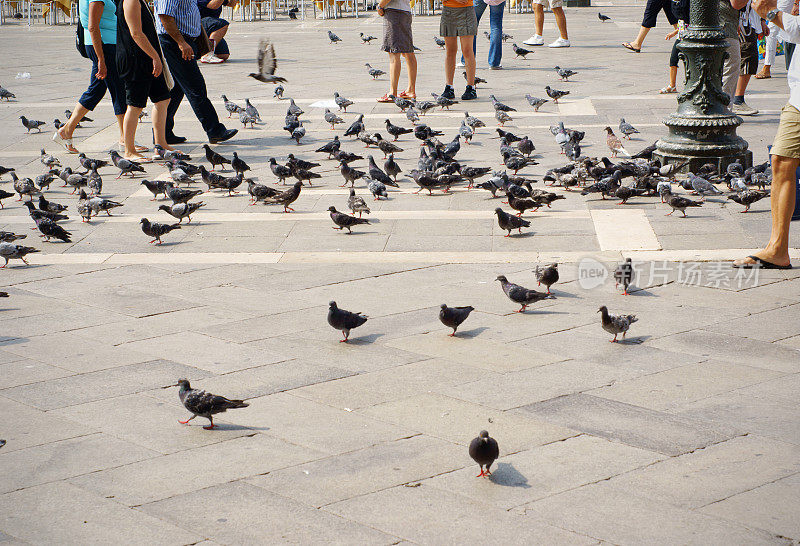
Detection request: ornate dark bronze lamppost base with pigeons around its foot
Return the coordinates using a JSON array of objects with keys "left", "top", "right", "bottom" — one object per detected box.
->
[{"left": 653, "top": 0, "right": 753, "bottom": 172}]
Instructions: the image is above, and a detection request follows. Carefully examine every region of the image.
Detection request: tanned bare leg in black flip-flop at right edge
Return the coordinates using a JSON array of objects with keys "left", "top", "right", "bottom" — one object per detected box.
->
[{"left": 734, "top": 155, "right": 800, "bottom": 265}]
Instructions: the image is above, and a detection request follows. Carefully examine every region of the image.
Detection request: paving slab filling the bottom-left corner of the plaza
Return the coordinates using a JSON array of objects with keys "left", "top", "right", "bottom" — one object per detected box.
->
[{"left": 0, "top": 482, "right": 202, "bottom": 545}]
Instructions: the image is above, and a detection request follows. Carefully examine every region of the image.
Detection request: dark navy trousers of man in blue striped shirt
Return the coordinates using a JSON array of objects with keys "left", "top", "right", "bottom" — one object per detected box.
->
[{"left": 158, "top": 34, "right": 225, "bottom": 137}]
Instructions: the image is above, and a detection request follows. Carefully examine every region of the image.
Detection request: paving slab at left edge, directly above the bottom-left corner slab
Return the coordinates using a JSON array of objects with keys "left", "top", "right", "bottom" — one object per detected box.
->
[{"left": 0, "top": 434, "right": 156, "bottom": 493}]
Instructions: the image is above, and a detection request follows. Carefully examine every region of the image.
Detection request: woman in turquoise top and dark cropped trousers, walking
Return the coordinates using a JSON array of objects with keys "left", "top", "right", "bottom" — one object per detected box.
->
[{"left": 53, "top": 0, "right": 131, "bottom": 154}]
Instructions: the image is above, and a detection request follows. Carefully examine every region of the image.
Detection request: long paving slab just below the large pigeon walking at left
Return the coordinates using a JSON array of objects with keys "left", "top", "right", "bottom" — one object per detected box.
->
[{"left": 70, "top": 432, "right": 324, "bottom": 506}]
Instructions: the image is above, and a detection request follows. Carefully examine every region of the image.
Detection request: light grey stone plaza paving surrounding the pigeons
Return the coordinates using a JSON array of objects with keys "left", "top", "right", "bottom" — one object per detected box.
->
[{"left": 0, "top": 3, "right": 800, "bottom": 545}]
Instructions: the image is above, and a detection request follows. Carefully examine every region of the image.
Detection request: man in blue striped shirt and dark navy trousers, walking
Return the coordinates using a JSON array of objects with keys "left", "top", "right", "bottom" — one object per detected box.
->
[{"left": 155, "top": 0, "right": 238, "bottom": 144}]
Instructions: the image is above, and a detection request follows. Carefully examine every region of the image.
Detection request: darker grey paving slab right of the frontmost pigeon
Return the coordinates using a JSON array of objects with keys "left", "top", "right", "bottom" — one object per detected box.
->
[{"left": 520, "top": 394, "right": 737, "bottom": 456}]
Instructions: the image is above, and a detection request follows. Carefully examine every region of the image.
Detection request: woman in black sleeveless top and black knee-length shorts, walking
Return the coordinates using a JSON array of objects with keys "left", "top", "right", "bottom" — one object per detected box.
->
[{"left": 116, "top": 0, "right": 172, "bottom": 161}]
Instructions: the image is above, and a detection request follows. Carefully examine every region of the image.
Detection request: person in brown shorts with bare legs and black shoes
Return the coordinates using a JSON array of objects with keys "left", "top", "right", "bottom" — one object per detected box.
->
[{"left": 439, "top": 0, "right": 480, "bottom": 100}]
